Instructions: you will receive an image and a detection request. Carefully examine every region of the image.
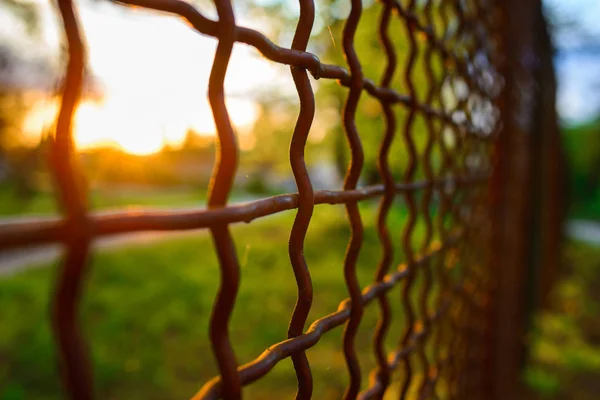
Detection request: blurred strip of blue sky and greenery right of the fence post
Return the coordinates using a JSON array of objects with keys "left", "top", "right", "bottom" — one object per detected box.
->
[{"left": 523, "top": 0, "right": 600, "bottom": 399}]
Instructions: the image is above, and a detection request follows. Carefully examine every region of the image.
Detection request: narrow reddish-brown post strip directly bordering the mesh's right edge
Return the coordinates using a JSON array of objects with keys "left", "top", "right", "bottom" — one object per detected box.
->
[{"left": 490, "top": 0, "right": 536, "bottom": 399}]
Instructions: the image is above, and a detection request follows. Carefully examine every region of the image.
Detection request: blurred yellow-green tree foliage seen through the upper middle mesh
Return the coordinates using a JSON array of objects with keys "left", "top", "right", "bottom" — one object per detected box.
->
[{"left": 241, "top": 0, "right": 452, "bottom": 184}]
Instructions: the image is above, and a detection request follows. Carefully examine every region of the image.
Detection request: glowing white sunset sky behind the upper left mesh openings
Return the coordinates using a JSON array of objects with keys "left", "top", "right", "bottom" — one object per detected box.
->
[{"left": 9, "top": 1, "right": 291, "bottom": 154}]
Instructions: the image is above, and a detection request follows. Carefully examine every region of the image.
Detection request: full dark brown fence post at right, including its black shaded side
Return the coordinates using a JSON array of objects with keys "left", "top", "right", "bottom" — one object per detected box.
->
[{"left": 490, "top": 0, "right": 565, "bottom": 399}]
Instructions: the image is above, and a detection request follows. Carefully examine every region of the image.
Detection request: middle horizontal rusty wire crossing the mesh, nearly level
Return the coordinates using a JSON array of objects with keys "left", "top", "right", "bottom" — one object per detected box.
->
[{"left": 0, "top": 175, "right": 488, "bottom": 250}]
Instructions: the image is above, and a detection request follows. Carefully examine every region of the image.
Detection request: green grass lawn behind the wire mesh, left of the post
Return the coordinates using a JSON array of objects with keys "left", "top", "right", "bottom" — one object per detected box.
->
[{"left": 0, "top": 203, "right": 446, "bottom": 400}]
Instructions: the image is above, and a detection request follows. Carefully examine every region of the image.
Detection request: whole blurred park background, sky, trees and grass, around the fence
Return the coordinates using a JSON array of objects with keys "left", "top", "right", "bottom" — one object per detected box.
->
[{"left": 0, "top": 0, "right": 600, "bottom": 399}]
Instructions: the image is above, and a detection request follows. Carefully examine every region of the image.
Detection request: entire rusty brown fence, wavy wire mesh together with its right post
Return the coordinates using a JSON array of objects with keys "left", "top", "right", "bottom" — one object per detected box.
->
[{"left": 0, "top": 0, "right": 560, "bottom": 399}]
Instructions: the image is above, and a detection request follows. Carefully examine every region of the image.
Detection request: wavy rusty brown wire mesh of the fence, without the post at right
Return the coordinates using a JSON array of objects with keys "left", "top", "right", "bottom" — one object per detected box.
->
[{"left": 0, "top": 0, "right": 502, "bottom": 399}]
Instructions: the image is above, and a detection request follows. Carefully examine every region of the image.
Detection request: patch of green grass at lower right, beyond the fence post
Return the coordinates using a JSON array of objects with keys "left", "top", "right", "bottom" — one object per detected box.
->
[{"left": 524, "top": 242, "right": 600, "bottom": 400}]
